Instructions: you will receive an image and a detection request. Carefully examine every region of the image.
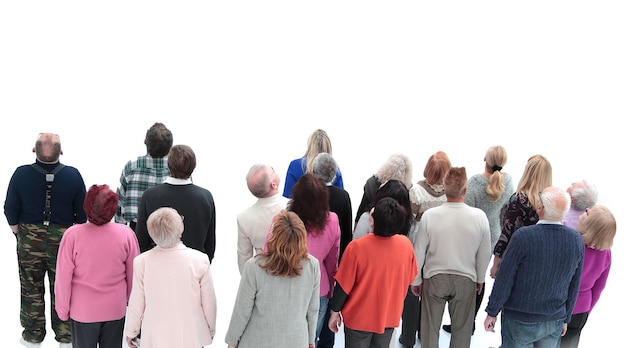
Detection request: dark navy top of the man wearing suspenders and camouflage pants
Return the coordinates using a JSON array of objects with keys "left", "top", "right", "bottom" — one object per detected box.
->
[{"left": 4, "top": 161, "right": 87, "bottom": 226}]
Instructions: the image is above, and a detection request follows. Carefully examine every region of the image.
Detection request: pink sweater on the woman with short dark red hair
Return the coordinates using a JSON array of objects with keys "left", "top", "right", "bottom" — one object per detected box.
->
[{"left": 54, "top": 222, "right": 139, "bottom": 323}]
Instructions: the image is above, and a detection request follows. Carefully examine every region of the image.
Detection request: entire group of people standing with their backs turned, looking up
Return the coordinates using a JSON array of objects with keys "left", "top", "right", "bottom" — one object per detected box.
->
[{"left": 5, "top": 127, "right": 616, "bottom": 348}]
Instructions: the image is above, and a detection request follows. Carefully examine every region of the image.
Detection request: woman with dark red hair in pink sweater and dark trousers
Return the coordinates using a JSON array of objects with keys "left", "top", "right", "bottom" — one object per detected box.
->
[{"left": 54, "top": 185, "right": 139, "bottom": 348}]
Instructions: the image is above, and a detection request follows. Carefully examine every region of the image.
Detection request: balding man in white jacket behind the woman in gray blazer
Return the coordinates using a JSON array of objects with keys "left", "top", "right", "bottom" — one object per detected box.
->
[{"left": 237, "top": 164, "right": 289, "bottom": 274}]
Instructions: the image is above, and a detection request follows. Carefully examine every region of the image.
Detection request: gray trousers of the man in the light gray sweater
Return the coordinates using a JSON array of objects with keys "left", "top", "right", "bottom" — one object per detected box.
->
[{"left": 420, "top": 274, "right": 476, "bottom": 348}]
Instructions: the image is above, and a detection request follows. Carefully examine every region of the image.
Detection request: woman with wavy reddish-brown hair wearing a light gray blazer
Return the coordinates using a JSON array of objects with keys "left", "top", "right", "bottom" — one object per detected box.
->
[{"left": 226, "top": 210, "right": 320, "bottom": 348}]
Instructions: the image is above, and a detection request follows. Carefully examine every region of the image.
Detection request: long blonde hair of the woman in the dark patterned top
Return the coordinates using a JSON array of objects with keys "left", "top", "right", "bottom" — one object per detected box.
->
[{"left": 515, "top": 155, "right": 552, "bottom": 210}]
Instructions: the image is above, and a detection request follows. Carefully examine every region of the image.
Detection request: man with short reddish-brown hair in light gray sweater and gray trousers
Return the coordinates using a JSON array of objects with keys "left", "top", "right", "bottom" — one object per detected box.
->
[{"left": 412, "top": 167, "right": 491, "bottom": 348}]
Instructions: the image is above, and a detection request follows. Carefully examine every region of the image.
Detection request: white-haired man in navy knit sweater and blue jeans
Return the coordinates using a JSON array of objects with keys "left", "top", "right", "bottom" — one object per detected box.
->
[{"left": 485, "top": 187, "right": 584, "bottom": 348}]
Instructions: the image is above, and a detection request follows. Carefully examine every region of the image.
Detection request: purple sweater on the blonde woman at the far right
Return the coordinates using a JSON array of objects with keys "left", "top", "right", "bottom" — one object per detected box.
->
[{"left": 572, "top": 246, "right": 611, "bottom": 314}]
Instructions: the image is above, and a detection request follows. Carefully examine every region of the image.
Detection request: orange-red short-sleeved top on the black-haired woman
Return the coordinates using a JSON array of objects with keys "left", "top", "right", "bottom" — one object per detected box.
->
[{"left": 335, "top": 234, "right": 418, "bottom": 333}]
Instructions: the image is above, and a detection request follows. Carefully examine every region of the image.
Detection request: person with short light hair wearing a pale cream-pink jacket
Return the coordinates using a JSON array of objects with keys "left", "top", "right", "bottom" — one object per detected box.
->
[{"left": 126, "top": 207, "right": 217, "bottom": 348}]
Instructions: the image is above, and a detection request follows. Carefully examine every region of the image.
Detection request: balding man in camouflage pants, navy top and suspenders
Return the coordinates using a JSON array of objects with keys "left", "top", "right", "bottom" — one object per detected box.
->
[{"left": 4, "top": 133, "right": 87, "bottom": 347}]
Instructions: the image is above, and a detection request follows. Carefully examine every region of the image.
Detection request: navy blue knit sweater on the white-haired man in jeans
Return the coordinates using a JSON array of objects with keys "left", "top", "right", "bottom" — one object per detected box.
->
[{"left": 485, "top": 221, "right": 585, "bottom": 323}]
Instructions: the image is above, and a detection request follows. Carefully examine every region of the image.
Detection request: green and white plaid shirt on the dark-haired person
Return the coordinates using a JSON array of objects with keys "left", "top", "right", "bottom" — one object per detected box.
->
[{"left": 115, "top": 155, "right": 170, "bottom": 224}]
